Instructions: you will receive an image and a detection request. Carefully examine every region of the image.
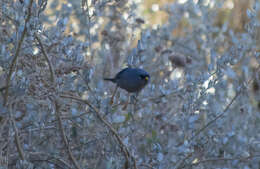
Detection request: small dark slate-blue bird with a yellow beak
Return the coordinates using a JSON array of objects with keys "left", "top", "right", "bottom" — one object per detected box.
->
[{"left": 104, "top": 67, "right": 150, "bottom": 109}]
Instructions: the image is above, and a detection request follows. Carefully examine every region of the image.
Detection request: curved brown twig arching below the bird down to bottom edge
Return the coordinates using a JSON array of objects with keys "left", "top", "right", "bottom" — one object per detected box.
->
[{"left": 61, "top": 95, "right": 137, "bottom": 169}]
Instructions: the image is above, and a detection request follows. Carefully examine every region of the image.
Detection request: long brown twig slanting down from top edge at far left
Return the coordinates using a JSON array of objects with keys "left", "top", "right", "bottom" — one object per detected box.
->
[{"left": 3, "top": 0, "right": 33, "bottom": 105}]
